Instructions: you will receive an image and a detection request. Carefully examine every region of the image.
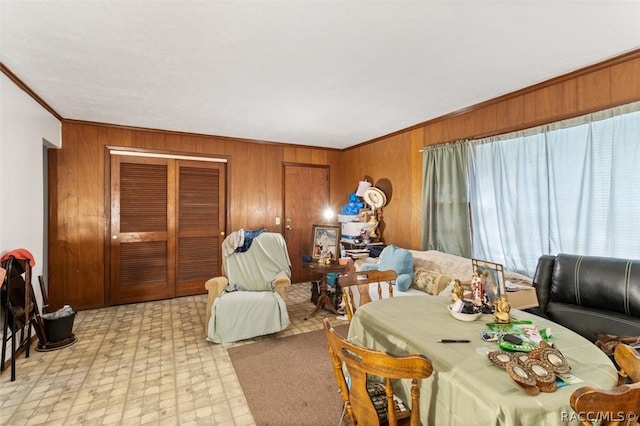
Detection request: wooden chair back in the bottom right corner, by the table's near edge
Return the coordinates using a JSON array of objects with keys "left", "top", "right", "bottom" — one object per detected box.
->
[{"left": 569, "top": 383, "right": 640, "bottom": 426}]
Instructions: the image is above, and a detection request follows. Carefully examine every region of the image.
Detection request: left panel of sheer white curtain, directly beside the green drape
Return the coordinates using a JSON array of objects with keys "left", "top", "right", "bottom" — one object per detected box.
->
[{"left": 469, "top": 133, "right": 549, "bottom": 275}]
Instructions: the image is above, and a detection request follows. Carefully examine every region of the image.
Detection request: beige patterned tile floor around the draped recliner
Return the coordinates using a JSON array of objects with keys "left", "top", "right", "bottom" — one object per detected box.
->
[{"left": 0, "top": 283, "right": 344, "bottom": 426}]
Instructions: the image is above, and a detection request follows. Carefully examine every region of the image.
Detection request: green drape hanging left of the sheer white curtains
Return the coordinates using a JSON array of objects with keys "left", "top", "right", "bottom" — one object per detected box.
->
[{"left": 421, "top": 141, "right": 471, "bottom": 257}]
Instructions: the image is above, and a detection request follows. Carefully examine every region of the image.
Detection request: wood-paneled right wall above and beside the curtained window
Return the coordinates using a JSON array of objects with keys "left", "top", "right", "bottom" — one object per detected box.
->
[{"left": 340, "top": 50, "right": 640, "bottom": 250}]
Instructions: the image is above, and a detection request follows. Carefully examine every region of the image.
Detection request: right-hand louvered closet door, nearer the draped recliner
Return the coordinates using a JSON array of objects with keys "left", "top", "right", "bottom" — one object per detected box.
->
[{"left": 176, "top": 161, "right": 225, "bottom": 296}]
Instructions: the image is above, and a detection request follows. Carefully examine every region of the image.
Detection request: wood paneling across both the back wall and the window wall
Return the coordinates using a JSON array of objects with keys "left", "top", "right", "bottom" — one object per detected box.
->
[{"left": 48, "top": 50, "right": 640, "bottom": 309}]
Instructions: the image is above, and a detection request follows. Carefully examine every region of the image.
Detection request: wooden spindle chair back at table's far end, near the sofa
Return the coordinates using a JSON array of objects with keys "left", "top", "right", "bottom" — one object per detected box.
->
[{"left": 338, "top": 270, "right": 398, "bottom": 321}]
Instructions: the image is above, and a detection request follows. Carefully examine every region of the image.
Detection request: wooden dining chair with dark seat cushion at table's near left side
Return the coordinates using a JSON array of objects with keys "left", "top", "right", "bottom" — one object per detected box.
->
[{"left": 323, "top": 318, "right": 433, "bottom": 426}]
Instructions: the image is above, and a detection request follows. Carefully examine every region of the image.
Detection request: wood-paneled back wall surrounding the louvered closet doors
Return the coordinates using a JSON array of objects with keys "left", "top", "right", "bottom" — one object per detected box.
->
[{"left": 48, "top": 121, "right": 342, "bottom": 309}]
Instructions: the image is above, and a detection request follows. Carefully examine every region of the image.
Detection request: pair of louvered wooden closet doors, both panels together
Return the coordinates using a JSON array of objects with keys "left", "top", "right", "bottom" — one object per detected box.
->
[{"left": 109, "top": 151, "right": 226, "bottom": 305}]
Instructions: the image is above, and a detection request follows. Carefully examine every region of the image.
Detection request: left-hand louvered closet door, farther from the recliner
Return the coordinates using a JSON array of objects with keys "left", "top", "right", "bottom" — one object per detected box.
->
[{"left": 110, "top": 155, "right": 176, "bottom": 304}]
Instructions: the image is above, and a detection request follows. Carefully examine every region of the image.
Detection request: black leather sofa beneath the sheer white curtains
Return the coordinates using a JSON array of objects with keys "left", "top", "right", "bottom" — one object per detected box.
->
[{"left": 528, "top": 254, "right": 640, "bottom": 342}]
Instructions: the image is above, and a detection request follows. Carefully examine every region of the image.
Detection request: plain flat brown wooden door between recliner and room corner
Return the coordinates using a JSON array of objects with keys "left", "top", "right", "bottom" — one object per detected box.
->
[{"left": 284, "top": 164, "right": 329, "bottom": 283}]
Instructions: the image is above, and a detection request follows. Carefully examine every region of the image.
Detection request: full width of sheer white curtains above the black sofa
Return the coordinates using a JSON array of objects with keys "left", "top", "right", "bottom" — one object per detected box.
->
[{"left": 469, "top": 102, "right": 640, "bottom": 276}]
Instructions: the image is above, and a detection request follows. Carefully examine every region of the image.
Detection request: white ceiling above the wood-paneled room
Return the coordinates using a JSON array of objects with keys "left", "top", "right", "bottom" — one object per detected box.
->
[{"left": 0, "top": 0, "right": 640, "bottom": 148}]
